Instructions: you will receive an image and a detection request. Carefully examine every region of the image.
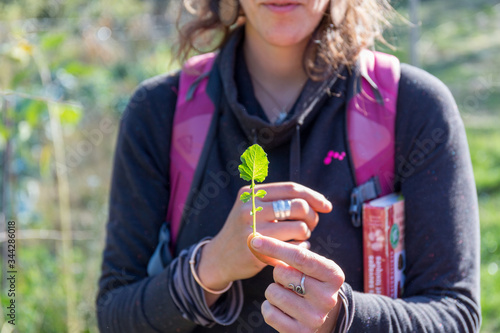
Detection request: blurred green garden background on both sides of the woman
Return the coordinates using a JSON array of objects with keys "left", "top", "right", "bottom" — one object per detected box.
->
[{"left": 0, "top": 0, "right": 500, "bottom": 333}]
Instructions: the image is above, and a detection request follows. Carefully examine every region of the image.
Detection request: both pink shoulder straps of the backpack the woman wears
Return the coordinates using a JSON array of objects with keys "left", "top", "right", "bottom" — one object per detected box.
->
[{"left": 167, "top": 50, "right": 400, "bottom": 243}]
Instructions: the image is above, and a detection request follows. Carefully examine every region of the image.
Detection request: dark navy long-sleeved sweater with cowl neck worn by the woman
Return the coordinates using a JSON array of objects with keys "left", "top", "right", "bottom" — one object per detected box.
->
[{"left": 97, "top": 29, "right": 480, "bottom": 333}]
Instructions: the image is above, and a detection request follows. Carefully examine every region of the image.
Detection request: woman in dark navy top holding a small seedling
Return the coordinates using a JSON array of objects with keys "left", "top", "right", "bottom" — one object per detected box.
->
[{"left": 97, "top": 0, "right": 480, "bottom": 333}]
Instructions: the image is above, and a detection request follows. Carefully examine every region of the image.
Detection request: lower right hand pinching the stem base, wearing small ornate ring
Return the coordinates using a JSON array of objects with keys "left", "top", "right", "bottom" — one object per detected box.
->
[{"left": 251, "top": 236, "right": 344, "bottom": 332}]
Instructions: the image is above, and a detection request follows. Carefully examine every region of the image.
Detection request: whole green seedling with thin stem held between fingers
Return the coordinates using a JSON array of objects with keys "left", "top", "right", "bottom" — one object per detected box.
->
[{"left": 238, "top": 144, "right": 269, "bottom": 236}]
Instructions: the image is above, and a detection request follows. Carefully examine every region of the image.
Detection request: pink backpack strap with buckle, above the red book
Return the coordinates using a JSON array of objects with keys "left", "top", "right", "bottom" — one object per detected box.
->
[{"left": 347, "top": 50, "right": 401, "bottom": 226}]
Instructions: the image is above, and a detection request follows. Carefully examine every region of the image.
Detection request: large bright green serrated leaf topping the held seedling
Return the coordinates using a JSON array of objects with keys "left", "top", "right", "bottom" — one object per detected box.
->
[{"left": 238, "top": 144, "right": 269, "bottom": 182}]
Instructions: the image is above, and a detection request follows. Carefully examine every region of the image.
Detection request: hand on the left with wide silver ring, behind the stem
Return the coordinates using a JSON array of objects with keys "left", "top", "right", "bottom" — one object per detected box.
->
[{"left": 198, "top": 183, "right": 332, "bottom": 290}]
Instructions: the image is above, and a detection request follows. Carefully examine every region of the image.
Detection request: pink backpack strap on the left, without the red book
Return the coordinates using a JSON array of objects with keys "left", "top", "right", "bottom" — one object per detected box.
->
[{"left": 167, "top": 53, "right": 216, "bottom": 243}]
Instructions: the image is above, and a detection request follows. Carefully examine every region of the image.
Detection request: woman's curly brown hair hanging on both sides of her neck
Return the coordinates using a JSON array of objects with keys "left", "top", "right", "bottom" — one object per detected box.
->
[{"left": 175, "top": 0, "right": 394, "bottom": 80}]
